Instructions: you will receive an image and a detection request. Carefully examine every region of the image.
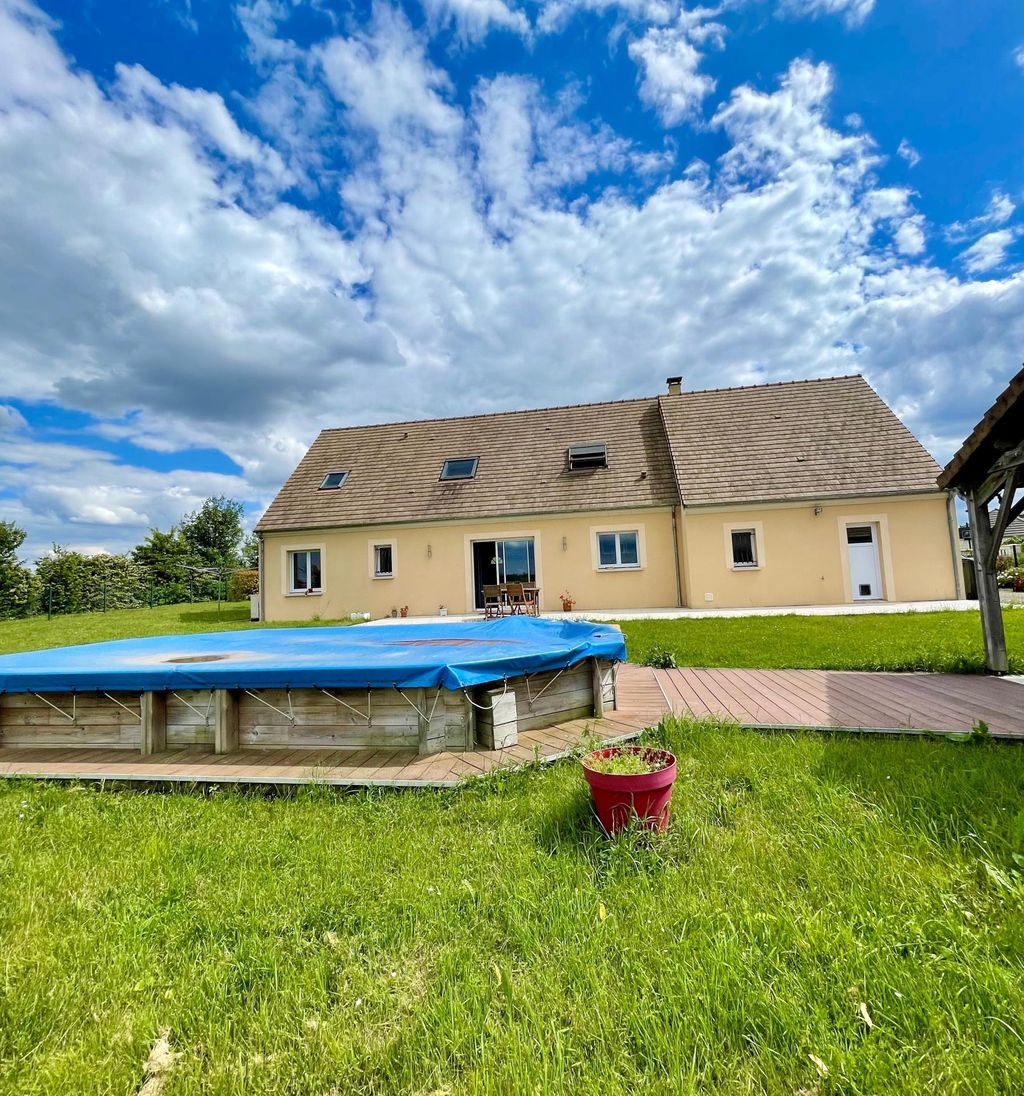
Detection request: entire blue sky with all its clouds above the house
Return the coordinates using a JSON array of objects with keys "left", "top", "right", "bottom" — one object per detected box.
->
[{"left": 0, "top": 0, "right": 1024, "bottom": 556}]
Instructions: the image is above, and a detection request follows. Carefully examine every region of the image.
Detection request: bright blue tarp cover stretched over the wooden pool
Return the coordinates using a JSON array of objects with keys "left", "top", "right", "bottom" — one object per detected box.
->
[{"left": 0, "top": 617, "right": 626, "bottom": 693}]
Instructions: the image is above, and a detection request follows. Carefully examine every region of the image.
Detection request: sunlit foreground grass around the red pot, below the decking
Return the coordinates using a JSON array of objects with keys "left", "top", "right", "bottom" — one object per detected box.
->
[{"left": 0, "top": 723, "right": 1024, "bottom": 1096}]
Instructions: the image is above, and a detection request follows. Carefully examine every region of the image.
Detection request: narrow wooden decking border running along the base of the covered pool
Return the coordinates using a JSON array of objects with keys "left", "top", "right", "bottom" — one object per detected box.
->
[{"left": 0, "top": 666, "right": 668, "bottom": 788}]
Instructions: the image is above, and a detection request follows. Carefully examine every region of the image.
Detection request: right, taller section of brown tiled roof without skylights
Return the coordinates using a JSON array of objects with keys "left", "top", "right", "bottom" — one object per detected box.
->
[{"left": 661, "top": 376, "right": 938, "bottom": 505}]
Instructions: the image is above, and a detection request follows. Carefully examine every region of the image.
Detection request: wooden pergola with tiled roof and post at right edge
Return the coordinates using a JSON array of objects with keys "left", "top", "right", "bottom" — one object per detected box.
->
[{"left": 938, "top": 368, "right": 1024, "bottom": 674}]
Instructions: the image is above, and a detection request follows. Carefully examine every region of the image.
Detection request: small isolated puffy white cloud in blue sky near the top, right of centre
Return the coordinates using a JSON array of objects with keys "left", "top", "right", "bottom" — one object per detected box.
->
[{"left": 629, "top": 8, "right": 725, "bottom": 126}]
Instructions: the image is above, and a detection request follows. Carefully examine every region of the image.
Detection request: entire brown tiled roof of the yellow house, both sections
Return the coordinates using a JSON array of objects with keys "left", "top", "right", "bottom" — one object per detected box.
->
[{"left": 257, "top": 377, "right": 938, "bottom": 532}]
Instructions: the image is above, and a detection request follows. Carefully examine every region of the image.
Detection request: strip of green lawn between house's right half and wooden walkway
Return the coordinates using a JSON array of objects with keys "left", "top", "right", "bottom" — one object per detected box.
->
[{"left": 623, "top": 609, "right": 1024, "bottom": 673}]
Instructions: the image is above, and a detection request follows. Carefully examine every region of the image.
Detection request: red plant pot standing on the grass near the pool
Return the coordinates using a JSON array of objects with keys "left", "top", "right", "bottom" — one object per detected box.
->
[{"left": 583, "top": 746, "right": 675, "bottom": 836}]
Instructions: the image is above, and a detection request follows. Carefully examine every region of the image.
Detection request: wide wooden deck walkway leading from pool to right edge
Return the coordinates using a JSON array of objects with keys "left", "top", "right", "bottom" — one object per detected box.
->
[{"left": 655, "top": 669, "right": 1024, "bottom": 740}]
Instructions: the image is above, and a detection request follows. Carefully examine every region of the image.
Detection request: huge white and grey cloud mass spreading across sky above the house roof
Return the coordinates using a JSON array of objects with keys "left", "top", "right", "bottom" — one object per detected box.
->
[{"left": 0, "top": 0, "right": 1024, "bottom": 556}]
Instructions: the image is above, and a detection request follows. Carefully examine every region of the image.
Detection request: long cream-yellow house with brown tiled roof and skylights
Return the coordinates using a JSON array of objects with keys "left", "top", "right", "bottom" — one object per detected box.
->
[{"left": 257, "top": 376, "right": 959, "bottom": 620}]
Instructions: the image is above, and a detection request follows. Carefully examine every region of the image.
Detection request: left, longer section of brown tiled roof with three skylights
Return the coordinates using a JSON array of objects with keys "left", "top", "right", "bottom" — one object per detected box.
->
[{"left": 257, "top": 398, "right": 678, "bottom": 532}]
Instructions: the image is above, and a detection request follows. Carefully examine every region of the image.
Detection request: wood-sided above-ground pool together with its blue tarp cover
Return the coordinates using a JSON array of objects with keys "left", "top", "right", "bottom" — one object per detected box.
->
[{"left": 0, "top": 617, "right": 626, "bottom": 754}]
